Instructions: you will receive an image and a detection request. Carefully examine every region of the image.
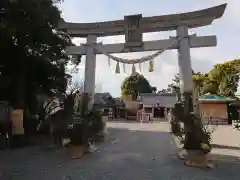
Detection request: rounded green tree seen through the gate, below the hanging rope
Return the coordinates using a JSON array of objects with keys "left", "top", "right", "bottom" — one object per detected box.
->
[{"left": 121, "top": 73, "right": 153, "bottom": 101}]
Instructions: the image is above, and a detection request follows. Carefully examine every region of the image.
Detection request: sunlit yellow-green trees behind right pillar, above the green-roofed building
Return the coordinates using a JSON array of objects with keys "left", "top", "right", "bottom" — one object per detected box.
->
[{"left": 159, "top": 59, "right": 240, "bottom": 97}]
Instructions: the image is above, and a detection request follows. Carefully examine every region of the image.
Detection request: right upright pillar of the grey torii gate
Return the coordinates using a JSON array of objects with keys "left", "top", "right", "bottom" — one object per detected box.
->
[{"left": 177, "top": 25, "right": 193, "bottom": 113}]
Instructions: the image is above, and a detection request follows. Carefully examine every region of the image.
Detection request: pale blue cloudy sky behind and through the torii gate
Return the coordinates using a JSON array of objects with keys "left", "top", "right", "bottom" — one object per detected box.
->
[{"left": 60, "top": 0, "right": 240, "bottom": 96}]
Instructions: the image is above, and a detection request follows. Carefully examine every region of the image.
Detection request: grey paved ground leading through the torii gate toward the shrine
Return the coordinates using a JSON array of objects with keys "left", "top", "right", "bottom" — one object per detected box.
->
[{"left": 0, "top": 122, "right": 240, "bottom": 180}]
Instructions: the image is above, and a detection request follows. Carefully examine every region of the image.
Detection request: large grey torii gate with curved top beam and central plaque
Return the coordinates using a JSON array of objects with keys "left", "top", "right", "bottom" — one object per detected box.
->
[{"left": 59, "top": 4, "right": 227, "bottom": 104}]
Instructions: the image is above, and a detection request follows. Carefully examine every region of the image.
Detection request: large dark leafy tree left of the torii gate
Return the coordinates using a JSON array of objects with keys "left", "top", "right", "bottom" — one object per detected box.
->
[{"left": 0, "top": 0, "right": 71, "bottom": 109}]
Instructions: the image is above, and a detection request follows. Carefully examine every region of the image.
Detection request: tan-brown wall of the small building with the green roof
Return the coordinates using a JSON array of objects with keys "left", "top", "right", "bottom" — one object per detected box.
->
[{"left": 199, "top": 103, "right": 228, "bottom": 124}]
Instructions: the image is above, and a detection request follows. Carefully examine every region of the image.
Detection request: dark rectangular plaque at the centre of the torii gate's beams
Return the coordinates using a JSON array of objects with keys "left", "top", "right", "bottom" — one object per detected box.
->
[{"left": 124, "top": 14, "right": 143, "bottom": 50}]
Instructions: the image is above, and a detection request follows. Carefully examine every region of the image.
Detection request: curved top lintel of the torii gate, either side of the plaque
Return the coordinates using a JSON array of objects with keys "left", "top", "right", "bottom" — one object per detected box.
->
[{"left": 59, "top": 4, "right": 227, "bottom": 37}]
